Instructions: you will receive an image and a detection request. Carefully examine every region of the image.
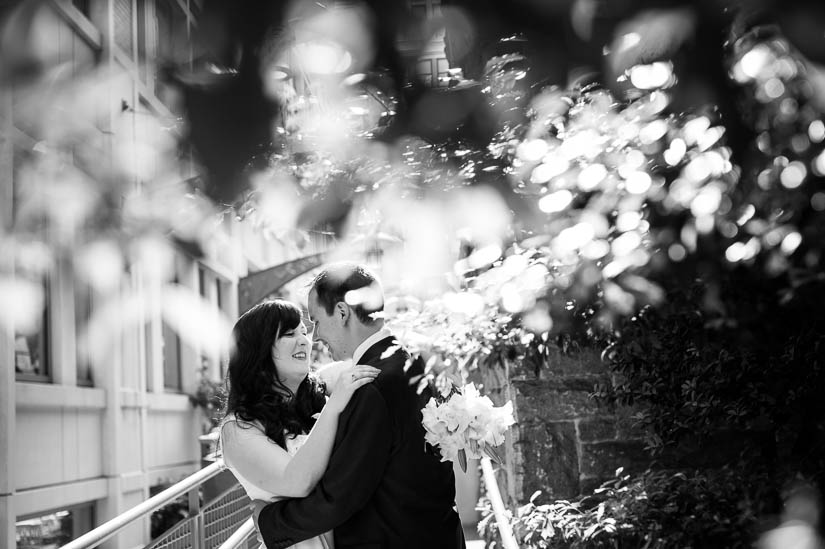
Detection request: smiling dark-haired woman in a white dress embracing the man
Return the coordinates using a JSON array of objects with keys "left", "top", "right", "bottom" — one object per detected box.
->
[{"left": 220, "top": 300, "right": 379, "bottom": 549}]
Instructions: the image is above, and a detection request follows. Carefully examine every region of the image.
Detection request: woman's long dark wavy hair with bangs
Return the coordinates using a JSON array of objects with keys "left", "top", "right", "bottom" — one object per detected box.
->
[{"left": 226, "top": 299, "right": 325, "bottom": 448}]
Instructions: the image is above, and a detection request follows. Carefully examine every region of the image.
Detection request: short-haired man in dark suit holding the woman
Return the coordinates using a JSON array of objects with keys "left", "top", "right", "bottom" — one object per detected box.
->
[{"left": 258, "top": 263, "right": 464, "bottom": 549}]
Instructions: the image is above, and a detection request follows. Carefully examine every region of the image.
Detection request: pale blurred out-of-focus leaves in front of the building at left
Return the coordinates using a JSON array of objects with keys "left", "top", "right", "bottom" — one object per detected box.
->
[{"left": 0, "top": 58, "right": 231, "bottom": 368}]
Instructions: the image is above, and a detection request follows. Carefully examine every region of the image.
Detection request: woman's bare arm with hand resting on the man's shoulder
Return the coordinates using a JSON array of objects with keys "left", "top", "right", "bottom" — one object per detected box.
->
[{"left": 222, "top": 366, "right": 379, "bottom": 498}]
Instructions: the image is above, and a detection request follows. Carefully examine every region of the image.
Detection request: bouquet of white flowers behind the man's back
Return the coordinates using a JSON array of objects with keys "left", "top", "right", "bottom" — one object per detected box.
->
[{"left": 421, "top": 383, "right": 516, "bottom": 472}]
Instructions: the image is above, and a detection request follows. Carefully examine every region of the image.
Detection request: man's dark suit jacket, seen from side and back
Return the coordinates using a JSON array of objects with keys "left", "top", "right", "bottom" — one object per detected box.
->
[{"left": 258, "top": 337, "right": 464, "bottom": 549}]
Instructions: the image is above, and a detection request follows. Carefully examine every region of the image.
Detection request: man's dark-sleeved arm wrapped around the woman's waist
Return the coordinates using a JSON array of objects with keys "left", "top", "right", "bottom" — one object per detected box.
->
[{"left": 258, "top": 385, "right": 392, "bottom": 549}]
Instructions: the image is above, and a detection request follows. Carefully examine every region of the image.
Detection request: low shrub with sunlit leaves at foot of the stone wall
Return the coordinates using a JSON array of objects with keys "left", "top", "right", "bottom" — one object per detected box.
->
[{"left": 479, "top": 468, "right": 761, "bottom": 549}]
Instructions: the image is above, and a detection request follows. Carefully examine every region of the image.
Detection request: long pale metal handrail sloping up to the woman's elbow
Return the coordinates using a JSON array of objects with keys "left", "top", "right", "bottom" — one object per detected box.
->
[{"left": 60, "top": 460, "right": 224, "bottom": 549}]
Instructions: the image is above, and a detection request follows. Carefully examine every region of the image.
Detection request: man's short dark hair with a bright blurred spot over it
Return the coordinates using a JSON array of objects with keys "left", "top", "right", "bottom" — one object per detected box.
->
[{"left": 311, "top": 263, "right": 384, "bottom": 325}]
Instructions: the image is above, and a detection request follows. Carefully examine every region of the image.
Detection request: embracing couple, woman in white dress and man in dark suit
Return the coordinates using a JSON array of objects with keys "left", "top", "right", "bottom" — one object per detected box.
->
[{"left": 221, "top": 263, "right": 465, "bottom": 549}]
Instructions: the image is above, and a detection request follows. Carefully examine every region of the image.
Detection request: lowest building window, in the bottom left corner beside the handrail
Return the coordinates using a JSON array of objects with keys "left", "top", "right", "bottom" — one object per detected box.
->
[{"left": 15, "top": 503, "right": 94, "bottom": 549}]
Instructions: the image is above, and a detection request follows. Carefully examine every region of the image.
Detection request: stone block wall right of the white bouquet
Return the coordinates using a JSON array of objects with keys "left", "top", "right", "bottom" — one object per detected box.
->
[{"left": 482, "top": 350, "right": 650, "bottom": 508}]
